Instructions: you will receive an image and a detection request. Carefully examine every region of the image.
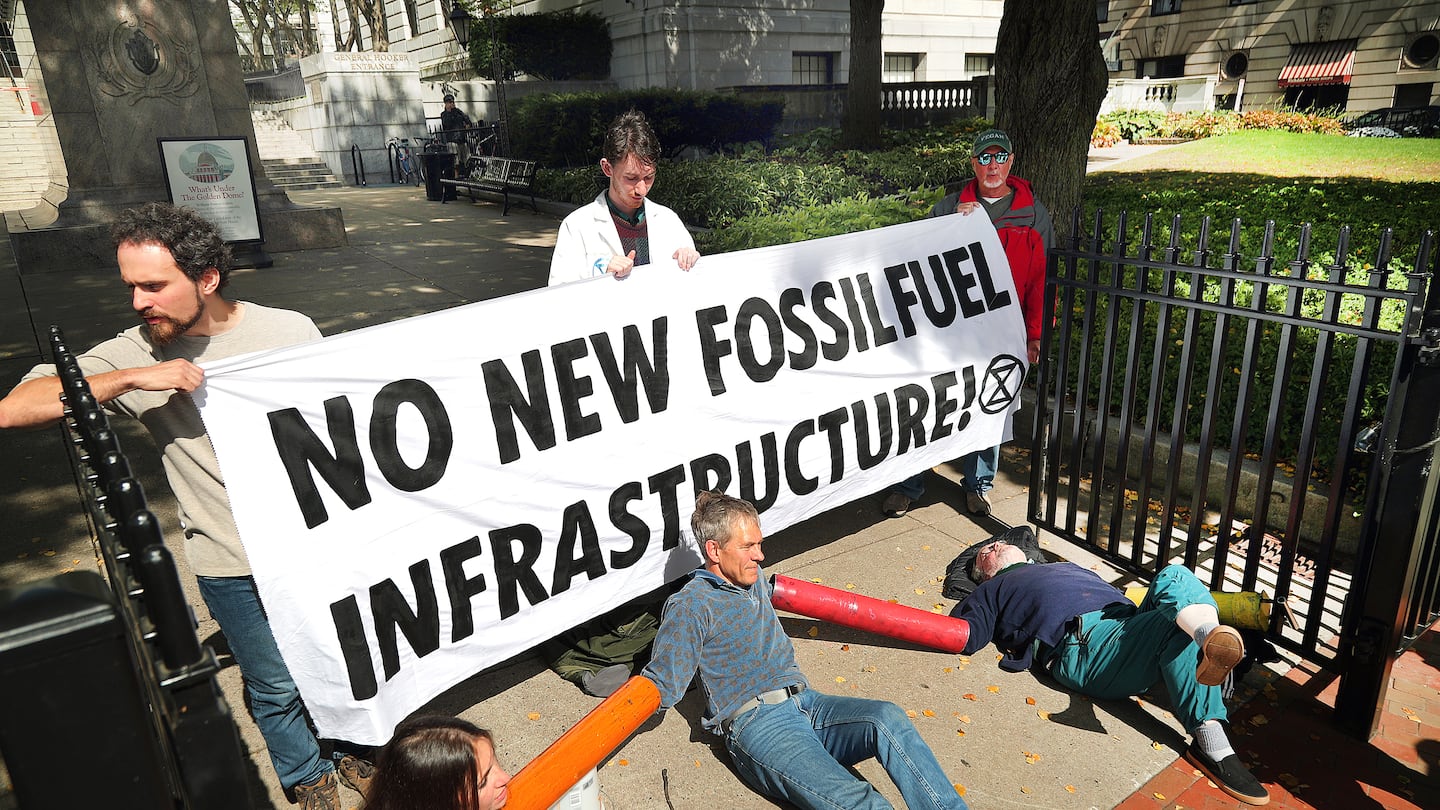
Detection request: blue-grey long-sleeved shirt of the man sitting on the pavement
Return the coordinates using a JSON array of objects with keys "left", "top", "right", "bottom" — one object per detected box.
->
[{"left": 644, "top": 568, "right": 809, "bottom": 734}]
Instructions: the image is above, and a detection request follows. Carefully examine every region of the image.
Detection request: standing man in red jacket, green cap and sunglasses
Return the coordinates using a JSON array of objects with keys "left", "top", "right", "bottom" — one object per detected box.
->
[{"left": 881, "top": 130, "right": 1054, "bottom": 517}]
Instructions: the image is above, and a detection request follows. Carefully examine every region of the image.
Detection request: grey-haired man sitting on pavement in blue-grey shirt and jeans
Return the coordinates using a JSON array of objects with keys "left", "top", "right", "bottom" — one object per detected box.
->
[{"left": 644, "top": 493, "right": 966, "bottom": 810}]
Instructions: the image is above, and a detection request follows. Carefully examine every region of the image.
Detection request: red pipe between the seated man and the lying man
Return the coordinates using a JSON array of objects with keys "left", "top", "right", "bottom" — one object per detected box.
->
[{"left": 770, "top": 574, "right": 971, "bottom": 653}]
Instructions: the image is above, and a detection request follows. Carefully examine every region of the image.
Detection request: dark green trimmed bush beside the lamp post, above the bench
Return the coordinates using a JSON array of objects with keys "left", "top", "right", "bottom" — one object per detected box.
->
[{"left": 469, "top": 12, "right": 612, "bottom": 79}]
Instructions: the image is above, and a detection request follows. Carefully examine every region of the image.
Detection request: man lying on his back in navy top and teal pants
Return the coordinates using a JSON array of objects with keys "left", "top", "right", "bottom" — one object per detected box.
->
[{"left": 950, "top": 540, "right": 1270, "bottom": 804}]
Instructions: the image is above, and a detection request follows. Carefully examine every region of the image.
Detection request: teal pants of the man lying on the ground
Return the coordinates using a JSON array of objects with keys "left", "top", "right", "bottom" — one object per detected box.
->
[{"left": 1050, "top": 565, "right": 1225, "bottom": 731}]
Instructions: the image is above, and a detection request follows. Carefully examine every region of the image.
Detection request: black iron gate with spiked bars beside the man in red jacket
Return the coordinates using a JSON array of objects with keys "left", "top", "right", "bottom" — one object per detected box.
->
[{"left": 1030, "top": 212, "right": 1440, "bottom": 736}]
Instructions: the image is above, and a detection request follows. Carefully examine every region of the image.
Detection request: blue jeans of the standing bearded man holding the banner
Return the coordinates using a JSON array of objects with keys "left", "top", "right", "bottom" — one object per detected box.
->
[{"left": 196, "top": 577, "right": 336, "bottom": 790}]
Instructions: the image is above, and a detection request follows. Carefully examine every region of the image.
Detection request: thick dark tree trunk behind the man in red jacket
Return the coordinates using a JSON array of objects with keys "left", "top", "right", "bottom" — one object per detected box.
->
[{"left": 995, "top": 0, "right": 1109, "bottom": 239}]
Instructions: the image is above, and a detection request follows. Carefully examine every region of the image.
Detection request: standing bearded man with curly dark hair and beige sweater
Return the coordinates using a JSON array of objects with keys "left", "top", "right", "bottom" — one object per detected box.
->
[{"left": 0, "top": 203, "right": 365, "bottom": 810}]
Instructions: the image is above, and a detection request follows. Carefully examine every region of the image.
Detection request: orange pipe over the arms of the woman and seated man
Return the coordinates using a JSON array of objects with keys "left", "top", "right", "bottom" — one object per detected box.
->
[{"left": 505, "top": 675, "right": 660, "bottom": 810}]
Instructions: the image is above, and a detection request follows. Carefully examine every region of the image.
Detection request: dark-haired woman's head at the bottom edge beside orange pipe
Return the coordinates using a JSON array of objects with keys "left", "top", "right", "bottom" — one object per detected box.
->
[{"left": 366, "top": 715, "right": 510, "bottom": 810}]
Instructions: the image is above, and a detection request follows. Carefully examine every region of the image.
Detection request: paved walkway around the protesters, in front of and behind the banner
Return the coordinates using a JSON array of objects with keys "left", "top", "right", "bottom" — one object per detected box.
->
[{"left": 0, "top": 186, "right": 1276, "bottom": 810}]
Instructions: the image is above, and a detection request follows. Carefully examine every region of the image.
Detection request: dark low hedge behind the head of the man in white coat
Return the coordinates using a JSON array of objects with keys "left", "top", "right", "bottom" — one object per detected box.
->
[{"left": 510, "top": 88, "right": 785, "bottom": 169}]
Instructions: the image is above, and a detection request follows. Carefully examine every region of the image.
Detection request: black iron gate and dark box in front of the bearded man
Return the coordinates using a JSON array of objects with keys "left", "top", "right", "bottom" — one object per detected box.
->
[{"left": 0, "top": 327, "right": 251, "bottom": 810}]
